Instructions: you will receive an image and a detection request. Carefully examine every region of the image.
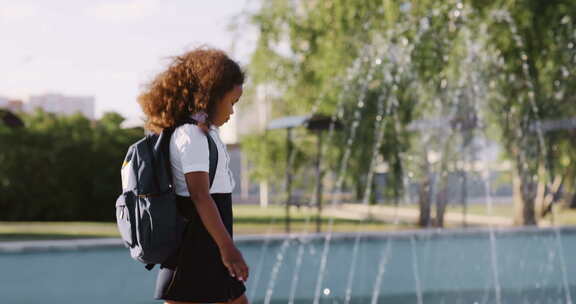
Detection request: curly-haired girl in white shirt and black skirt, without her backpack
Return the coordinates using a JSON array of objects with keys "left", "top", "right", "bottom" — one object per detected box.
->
[{"left": 138, "top": 48, "right": 248, "bottom": 304}]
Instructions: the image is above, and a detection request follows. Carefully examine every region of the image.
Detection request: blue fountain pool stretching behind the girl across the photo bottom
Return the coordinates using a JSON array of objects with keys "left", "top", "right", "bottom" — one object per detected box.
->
[{"left": 0, "top": 227, "right": 576, "bottom": 304}]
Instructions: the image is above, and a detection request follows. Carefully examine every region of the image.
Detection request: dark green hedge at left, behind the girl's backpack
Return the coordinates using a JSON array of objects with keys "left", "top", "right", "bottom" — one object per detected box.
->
[{"left": 0, "top": 111, "right": 143, "bottom": 221}]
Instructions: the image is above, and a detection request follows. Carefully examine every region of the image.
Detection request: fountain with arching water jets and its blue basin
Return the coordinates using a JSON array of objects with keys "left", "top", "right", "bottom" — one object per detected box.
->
[{"left": 0, "top": 1, "right": 576, "bottom": 304}]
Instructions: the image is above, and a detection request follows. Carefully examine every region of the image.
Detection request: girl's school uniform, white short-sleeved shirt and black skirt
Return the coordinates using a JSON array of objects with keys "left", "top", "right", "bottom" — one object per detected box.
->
[{"left": 154, "top": 124, "right": 246, "bottom": 303}]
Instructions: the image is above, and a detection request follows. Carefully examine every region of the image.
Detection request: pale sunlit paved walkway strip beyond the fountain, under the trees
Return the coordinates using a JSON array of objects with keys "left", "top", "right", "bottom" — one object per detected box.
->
[{"left": 323, "top": 204, "right": 513, "bottom": 226}]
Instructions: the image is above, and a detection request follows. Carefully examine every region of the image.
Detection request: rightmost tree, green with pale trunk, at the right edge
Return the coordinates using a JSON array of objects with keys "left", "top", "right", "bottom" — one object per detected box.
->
[{"left": 481, "top": 0, "right": 576, "bottom": 225}]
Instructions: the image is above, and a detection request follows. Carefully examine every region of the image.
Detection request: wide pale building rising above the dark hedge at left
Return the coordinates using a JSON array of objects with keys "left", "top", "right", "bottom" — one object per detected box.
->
[{"left": 24, "top": 94, "right": 95, "bottom": 120}]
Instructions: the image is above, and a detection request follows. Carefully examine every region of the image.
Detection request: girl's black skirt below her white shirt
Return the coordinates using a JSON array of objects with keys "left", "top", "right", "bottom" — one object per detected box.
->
[{"left": 154, "top": 193, "right": 246, "bottom": 303}]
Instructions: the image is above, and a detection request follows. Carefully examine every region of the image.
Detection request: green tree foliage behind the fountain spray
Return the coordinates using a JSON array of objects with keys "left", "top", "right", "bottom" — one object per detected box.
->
[{"left": 242, "top": 0, "right": 576, "bottom": 223}]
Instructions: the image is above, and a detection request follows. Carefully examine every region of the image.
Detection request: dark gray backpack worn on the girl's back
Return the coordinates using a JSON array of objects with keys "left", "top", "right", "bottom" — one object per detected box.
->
[{"left": 116, "top": 118, "right": 218, "bottom": 270}]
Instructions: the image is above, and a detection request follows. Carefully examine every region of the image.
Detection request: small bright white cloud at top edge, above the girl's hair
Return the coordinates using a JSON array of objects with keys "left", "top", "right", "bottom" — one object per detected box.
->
[{"left": 85, "top": 0, "right": 159, "bottom": 21}]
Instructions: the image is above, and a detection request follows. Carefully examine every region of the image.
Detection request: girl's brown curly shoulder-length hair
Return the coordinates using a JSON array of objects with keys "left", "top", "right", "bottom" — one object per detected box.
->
[{"left": 138, "top": 47, "right": 244, "bottom": 133}]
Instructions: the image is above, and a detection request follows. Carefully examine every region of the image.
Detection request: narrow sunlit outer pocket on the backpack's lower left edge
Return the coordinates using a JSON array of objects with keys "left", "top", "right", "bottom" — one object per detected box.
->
[{"left": 116, "top": 192, "right": 136, "bottom": 248}]
